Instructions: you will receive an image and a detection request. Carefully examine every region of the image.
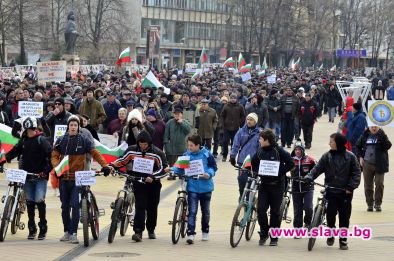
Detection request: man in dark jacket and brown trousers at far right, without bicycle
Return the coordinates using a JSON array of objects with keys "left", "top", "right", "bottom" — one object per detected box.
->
[{"left": 357, "top": 126, "right": 391, "bottom": 212}]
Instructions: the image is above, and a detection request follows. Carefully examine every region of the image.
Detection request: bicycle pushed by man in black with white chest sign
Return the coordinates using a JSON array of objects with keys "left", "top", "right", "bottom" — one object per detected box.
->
[{"left": 230, "top": 167, "right": 260, "bottom": 247}]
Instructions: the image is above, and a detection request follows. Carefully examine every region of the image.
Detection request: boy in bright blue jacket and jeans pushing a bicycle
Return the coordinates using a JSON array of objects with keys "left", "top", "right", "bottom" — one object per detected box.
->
[{"left": 172, "top": 135, "right": 217, "bottom": 244}]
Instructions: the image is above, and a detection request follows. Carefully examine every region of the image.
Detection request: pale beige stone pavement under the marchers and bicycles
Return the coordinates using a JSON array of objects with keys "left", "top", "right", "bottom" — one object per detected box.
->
[{"left": 0, "top": 117, "right": 394, "bottom": 260}]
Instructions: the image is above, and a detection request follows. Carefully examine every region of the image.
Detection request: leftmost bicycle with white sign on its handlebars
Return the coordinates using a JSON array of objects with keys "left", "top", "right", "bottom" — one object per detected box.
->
[{"left": 0, "top": 169, "right": 39, "bottom": 242}]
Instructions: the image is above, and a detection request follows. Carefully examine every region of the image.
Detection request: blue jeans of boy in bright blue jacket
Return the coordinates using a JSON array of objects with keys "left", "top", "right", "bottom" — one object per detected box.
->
[{"left": 187, "top": 191, "right": 212, "bottom": 235}]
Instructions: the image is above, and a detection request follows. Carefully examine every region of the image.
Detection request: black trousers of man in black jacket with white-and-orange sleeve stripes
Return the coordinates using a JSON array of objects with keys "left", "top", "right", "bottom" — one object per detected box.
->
[{"left": 133, "top": 181, "right": 161, "bottom": 233}]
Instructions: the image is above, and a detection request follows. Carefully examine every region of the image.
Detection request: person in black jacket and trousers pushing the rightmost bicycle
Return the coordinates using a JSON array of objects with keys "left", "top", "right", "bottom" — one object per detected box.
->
[{"left": 305, "top": 133, "right": 361, "bottom": 250}]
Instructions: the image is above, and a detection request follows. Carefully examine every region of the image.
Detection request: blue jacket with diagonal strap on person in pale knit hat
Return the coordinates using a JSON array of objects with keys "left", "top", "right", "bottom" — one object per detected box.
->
[{"left": 230, "top": 124, "right": 261, "bottom": 165}]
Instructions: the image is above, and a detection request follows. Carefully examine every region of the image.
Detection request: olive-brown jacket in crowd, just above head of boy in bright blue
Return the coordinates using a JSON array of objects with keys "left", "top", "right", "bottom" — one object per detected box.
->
[{"left": 196, "top": 107, "right": 218, "bottom": 139}]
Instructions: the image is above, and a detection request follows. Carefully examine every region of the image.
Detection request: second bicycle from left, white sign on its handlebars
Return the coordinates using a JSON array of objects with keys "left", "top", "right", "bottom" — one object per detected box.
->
[{"left": 75, "top": 171, "right": 105, "bottom": 247}]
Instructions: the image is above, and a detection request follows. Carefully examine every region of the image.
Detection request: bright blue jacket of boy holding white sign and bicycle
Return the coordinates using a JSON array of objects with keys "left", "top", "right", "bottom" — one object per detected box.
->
[{"left": 171, "top": 147, "right": 218, "bottom": 193}]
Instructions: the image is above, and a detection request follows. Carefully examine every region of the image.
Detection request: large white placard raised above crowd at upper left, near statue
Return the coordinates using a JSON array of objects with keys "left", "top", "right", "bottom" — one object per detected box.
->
[{"left": 37, "top": 61, "right": 67, "bottom": 84}]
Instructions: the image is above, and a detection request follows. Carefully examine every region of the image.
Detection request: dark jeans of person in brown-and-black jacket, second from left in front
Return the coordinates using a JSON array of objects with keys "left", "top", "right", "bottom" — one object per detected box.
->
[{"left": 59, "top": 180, "right": 79, "bottom": 235}]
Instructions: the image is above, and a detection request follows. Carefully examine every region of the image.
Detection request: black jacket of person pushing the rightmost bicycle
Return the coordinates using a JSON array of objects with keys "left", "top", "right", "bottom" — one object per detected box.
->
[{"left": 309, "top": 150, "right": 361, "bottom": 193}]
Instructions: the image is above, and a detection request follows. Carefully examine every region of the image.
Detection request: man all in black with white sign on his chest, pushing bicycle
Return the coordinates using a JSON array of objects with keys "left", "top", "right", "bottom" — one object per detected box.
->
[{"left": 252, "top": 129, "right": 294, "bottom": 246}]
